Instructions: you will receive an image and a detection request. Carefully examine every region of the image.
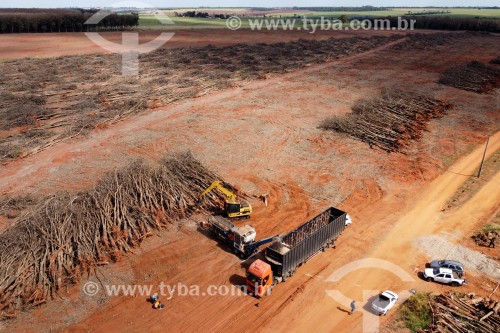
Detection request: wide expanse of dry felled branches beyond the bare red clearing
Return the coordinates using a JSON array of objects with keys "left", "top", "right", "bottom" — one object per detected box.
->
[{"left": 0, "top": 33, "right": 474, "bottom": 161}]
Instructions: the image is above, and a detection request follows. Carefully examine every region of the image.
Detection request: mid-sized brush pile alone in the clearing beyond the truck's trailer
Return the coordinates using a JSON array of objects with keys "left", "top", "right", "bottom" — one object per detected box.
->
[{"left": 320, "top": 90, "right": 450, "bottom": 153}]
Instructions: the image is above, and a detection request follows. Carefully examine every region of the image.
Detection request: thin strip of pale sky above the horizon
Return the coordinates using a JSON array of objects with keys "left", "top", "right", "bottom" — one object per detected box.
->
[{"left": 0, "top": 0, "right": 500, "bottom": 8}]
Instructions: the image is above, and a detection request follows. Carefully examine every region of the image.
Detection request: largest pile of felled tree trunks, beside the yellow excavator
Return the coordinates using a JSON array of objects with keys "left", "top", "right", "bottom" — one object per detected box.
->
[{"left": 0, "top": 153, "right": 232, "bottom": 319}]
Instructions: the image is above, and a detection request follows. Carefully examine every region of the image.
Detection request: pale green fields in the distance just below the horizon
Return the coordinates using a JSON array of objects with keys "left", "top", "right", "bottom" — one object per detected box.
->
[{"left": 139, "top": 8, "right": 500, "bottom": 29}]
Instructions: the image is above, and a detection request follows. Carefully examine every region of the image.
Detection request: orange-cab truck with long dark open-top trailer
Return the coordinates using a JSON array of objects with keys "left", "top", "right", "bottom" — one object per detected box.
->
[{"left": 246, "top": 207, "right": 347, "bottom": 297}]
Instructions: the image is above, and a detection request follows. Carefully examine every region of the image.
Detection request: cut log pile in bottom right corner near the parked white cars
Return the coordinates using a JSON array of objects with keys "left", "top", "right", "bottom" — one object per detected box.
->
[{"left": 431, "top": 293, "right": 500, "bottom": 333}]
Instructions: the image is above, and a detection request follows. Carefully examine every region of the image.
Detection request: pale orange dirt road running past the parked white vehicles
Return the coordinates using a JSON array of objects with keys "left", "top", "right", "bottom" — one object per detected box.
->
[{"left": 284, "top": 132, "right": 500, "bottom": 332}]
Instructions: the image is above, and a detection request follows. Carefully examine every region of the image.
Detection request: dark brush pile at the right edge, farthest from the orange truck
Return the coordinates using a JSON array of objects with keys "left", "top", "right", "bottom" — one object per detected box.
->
[{"left": 438, "top": 61, "right": 500, "bottom": 94}]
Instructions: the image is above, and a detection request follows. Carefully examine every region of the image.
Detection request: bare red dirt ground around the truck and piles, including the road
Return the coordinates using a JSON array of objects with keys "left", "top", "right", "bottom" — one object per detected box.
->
[{"left": 0, "top": 29, "right": 500, "bottom": 332}]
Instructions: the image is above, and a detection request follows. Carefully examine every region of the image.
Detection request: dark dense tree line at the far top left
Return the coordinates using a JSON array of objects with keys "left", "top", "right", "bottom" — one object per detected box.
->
[{"left": 0, "top": 9, "right": 139, "bottom": 34}]
